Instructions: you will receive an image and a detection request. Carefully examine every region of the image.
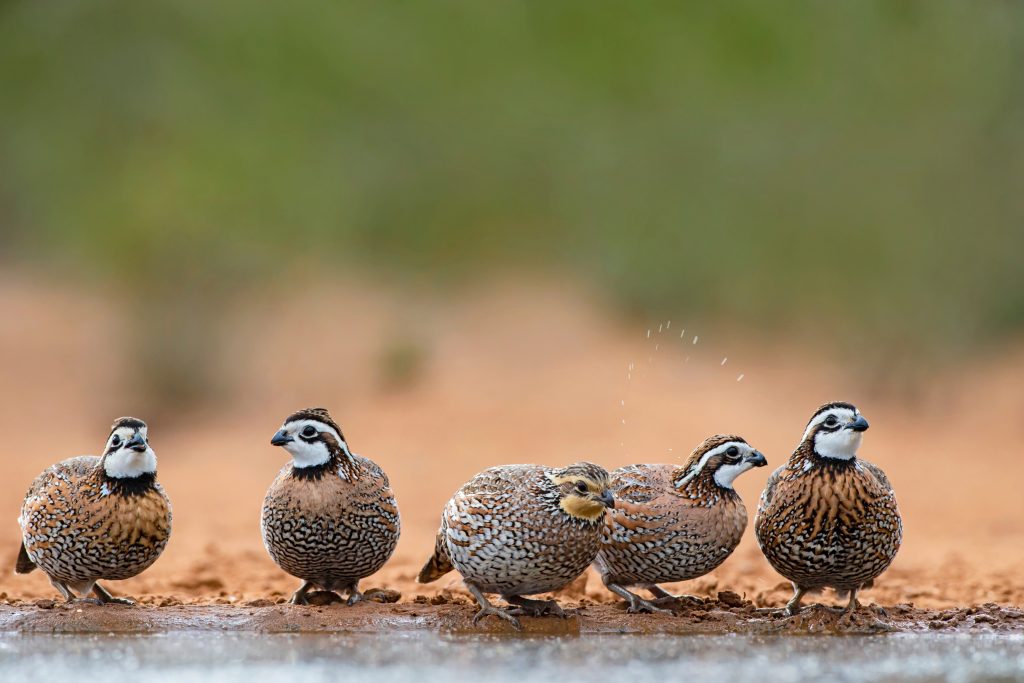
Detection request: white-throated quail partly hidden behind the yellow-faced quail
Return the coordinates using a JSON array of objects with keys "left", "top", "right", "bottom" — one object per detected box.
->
[{"left": 594, "top": 434, "right": 768, "bottom": 612}]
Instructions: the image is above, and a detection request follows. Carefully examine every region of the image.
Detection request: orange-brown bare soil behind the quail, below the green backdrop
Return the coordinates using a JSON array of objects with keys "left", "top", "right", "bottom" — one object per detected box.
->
[{"left": 0, "top": 275, "right": 1024, "bottom": 629}]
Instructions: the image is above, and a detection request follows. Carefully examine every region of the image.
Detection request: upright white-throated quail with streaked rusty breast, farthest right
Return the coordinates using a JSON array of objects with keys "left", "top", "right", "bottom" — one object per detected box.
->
[{"left": 754, "top": 401, "right": 903, "bottom": 616}]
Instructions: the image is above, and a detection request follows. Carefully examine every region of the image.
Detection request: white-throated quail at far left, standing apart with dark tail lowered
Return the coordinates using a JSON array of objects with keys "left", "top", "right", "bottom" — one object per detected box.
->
[{"left": 14, "top": 417, "right": 171, "bottom": 604}]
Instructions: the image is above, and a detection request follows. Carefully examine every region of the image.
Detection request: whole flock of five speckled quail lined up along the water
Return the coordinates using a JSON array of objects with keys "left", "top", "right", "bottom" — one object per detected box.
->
[{"left": 16, "top": 402, "right": 902, "bottom": 628}]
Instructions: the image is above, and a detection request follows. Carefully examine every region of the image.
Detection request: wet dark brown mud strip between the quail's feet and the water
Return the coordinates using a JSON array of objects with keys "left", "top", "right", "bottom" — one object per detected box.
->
[{"left": 0, "top": 596, "right": 1024, "bottom": 635}]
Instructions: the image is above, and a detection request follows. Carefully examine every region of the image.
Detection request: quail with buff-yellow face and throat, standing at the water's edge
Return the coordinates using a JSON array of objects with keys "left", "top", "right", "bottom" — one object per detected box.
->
[{"left": 418, "top": 462, "right": 614, "bottom": 630}]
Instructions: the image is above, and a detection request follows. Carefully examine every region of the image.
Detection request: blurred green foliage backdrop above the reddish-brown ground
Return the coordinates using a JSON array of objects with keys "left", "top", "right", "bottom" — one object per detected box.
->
[{"left": 0, "top": 0, "right": 1024, "bottom": 405}]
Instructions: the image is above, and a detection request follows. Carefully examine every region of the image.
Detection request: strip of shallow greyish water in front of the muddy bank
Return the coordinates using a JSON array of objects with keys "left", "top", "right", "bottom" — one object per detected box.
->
[{"left": 0, "top": 632, "right": 1024, "bottom": 683}]
